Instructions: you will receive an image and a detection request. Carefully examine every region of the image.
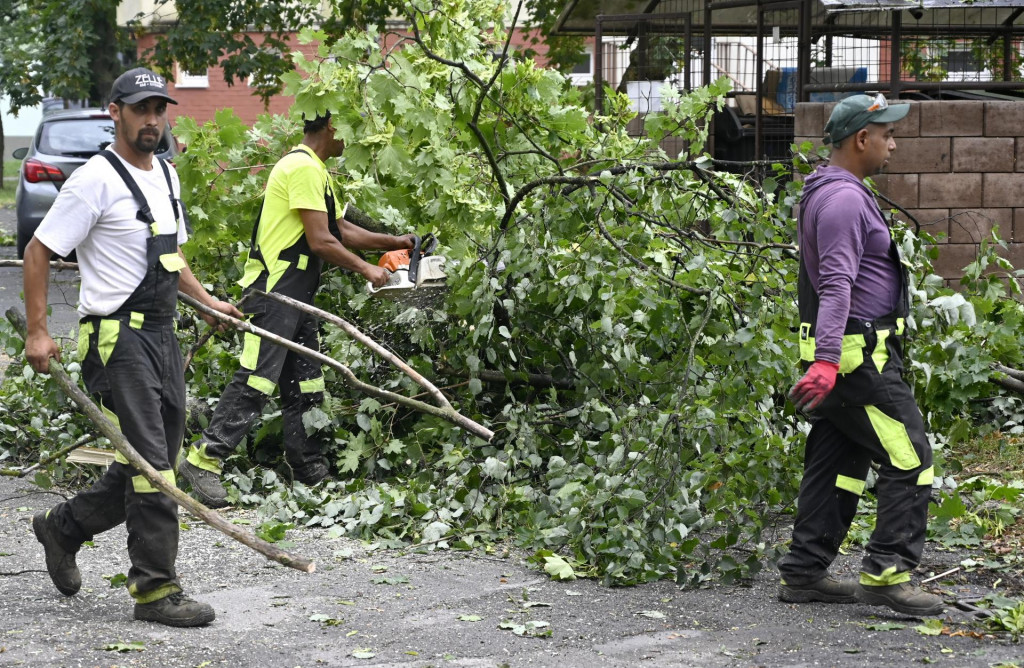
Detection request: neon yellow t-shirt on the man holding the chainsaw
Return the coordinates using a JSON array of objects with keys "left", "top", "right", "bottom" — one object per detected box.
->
[{"left": 239, "top": 144, "right": 343, "bottom": 288}]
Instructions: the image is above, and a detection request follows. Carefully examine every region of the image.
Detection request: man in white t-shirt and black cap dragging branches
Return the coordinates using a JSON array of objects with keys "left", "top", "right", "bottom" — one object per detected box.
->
[{"left": 25, "top": 68, "right": 242, "bottom": 626}]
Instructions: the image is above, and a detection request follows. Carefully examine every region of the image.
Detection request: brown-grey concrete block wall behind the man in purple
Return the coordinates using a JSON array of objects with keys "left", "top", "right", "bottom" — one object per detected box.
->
[{"left": 795, "top": 100, "right": 1024, "bottom": 284}]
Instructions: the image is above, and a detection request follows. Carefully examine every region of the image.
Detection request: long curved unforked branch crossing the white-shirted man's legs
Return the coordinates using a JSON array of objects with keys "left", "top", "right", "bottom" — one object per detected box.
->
[{"left": 7, "top": 308, "right": 316, "bottom": 573}]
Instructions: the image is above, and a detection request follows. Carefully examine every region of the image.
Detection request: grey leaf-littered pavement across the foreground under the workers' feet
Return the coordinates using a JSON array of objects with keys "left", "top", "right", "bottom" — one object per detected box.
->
[{"left": 0, "top": 469, "right": 1024, "bottom": 668}]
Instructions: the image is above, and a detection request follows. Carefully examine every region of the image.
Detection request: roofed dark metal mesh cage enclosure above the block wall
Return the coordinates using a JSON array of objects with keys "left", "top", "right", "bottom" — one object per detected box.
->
[{"left": 556, "top": 0, "right": 1024, "bottom": 161}]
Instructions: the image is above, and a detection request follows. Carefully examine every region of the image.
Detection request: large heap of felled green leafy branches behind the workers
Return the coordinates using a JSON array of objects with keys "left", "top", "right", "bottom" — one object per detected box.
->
[{"left": 0, "top": 0, "right": 1024, "bottom": 594}]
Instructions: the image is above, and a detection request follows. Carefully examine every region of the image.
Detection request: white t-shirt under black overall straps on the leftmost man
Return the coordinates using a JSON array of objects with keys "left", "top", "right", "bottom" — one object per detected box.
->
[{"left": 36, "top": 153, "right": 188, "bottom": 316}]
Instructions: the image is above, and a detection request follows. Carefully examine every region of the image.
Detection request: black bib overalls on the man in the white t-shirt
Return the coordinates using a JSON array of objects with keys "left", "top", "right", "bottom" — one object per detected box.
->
[{"left": 50, "top": 151, "right": 185, "bottom": 603}]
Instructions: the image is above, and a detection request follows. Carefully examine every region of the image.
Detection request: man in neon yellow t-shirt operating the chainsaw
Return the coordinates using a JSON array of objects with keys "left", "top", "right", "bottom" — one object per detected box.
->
[{"left": 178, "top": 113, "right": 414, "bottom": 507}]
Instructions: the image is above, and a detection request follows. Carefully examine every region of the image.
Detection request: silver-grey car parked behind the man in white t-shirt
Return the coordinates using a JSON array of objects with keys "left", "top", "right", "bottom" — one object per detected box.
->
[{"left": 13, "top": 109, "right": 178, "bottom": 258}]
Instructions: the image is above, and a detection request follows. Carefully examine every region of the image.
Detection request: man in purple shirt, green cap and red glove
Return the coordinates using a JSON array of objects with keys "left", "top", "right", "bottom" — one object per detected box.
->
[{"left": 778, "top": 95, "right": 943, "bottom": 616}]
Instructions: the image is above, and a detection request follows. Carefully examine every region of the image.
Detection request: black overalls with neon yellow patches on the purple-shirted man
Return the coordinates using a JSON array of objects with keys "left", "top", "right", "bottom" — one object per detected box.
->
[{"left": 778, "top": 211, "right": 933, "bottom": 586}]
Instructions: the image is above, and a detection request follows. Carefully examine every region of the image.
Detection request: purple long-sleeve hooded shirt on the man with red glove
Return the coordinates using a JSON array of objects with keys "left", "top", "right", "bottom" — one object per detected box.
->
[{"left": 799, "top": 166, "right": 900, "bottom": 364}]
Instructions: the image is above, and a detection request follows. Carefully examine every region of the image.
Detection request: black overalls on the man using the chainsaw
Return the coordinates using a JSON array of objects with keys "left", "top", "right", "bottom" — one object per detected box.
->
[{"left": 188, "top": 150, "right": 333, "bottom": 477}]
